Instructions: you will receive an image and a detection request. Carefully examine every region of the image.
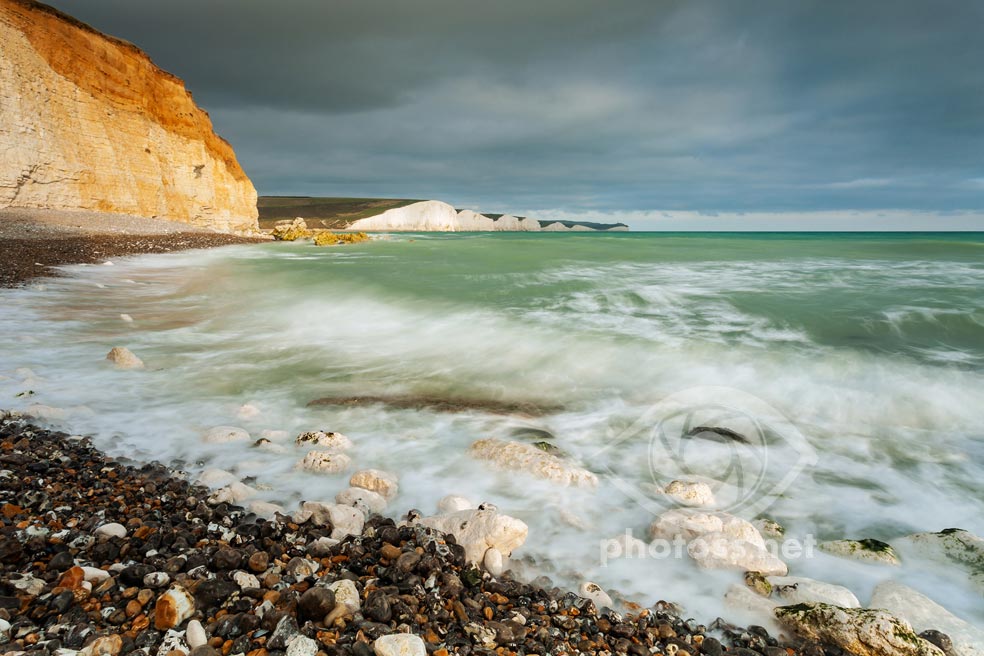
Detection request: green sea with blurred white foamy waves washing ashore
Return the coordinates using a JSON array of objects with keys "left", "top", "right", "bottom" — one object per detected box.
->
[{"left": 0, "top": 232, "right": 984, "bottom": 625}]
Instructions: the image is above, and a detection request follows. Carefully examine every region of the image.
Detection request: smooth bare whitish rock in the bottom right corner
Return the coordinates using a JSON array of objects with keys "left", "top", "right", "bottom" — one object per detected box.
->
[{"left": 868, "top": 581, "right": 984, "bottom": 656}]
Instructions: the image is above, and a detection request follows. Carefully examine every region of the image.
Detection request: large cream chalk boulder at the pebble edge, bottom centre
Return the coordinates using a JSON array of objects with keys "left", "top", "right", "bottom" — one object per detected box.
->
[{"left": 420, "top": 509, "right": 529, "bottom": 565}]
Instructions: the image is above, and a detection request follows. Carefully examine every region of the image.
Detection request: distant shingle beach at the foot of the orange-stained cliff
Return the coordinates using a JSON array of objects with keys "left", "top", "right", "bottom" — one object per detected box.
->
[{"left": 0, "top": 208, "right": 269, "bottom": 287}]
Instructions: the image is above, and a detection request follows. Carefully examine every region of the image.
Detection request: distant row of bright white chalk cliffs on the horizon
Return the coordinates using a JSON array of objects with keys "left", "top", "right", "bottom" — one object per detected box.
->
[{"left": 348, "top": 200, "right": 626, "bottom": 232}]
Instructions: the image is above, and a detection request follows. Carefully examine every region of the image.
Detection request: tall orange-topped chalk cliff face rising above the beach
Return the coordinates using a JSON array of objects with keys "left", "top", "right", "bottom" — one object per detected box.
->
[{"left": 0, "top": 0, "right": 257, "bottom": 232}]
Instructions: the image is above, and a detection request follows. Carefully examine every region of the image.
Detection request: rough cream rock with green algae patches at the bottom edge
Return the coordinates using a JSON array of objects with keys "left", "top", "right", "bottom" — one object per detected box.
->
[{"left": 775, "top": 604, "right": 943, "bottom": 656}]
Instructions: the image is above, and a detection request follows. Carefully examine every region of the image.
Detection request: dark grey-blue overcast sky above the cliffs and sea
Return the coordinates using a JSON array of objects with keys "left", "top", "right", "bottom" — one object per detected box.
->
[{"left": 51, "top": 0, "right": 984, "bottom": 229}]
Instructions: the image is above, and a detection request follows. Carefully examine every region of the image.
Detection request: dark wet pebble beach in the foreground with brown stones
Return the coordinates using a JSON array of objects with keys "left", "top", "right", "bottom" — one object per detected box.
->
[{"left": 0, "top": 413, "right": 816, "bottom": 656}]
